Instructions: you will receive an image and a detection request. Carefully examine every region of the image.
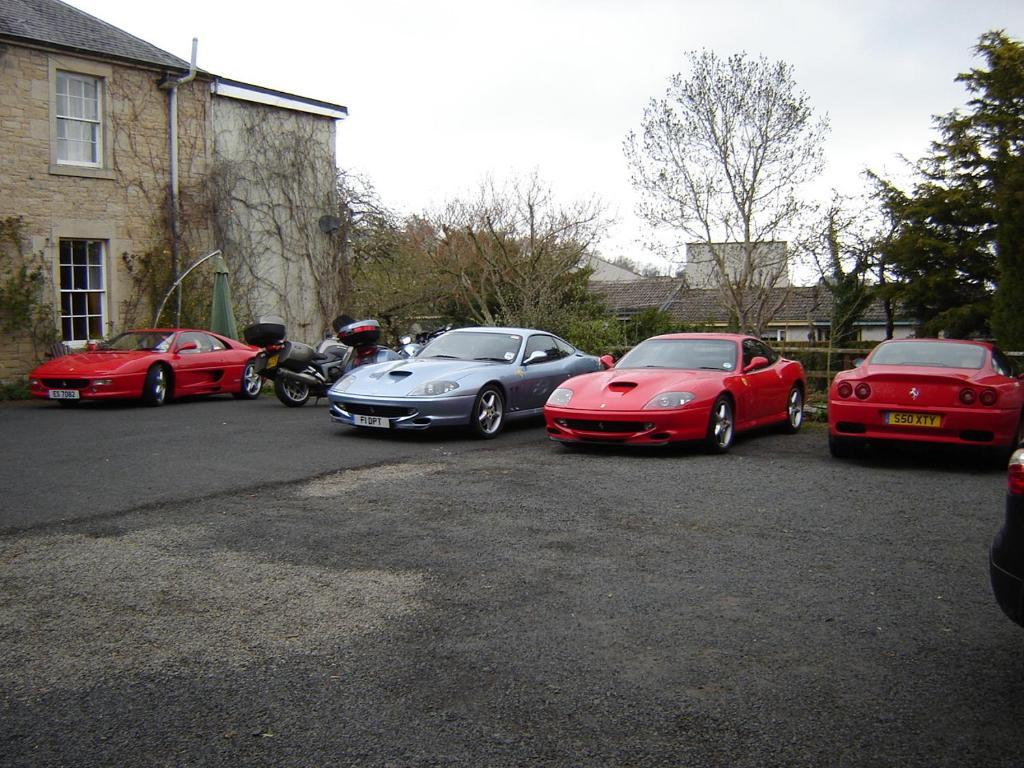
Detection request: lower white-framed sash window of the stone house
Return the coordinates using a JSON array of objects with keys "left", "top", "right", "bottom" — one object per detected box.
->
[{"left": 60, "top": 240, "right": 106, "bottom": 343}]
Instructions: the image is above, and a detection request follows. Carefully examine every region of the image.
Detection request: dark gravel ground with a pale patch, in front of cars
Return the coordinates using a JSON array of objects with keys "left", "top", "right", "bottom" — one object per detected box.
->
[{"left": 0, "top": 425, "right": 1024, "bottom": 768}]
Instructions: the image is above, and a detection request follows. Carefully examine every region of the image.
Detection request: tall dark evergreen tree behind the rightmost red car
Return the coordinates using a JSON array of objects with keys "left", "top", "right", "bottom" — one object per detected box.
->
[{"left": 876, "top": 32, "right": 1024, "bottom": 348}]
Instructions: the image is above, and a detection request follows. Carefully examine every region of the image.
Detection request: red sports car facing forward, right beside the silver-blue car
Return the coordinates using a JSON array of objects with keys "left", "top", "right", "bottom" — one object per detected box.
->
[{"left": 544, "top": 333, "right": 807, "bottom": 453}]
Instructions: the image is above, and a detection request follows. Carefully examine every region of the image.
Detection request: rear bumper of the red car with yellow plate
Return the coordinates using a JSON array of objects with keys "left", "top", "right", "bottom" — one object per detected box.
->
[{"left": 828, "top": 398, "right": 1018, "bottom": 446}]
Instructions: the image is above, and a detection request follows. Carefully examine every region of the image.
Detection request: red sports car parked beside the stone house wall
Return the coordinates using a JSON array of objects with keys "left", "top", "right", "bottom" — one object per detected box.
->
[{"left": 29, "top": 329, "right": 263, "bottom": 406}]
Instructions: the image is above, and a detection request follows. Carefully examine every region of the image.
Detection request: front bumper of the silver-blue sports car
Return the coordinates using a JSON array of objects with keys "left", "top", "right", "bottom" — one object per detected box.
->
[{"left": 328, "top": 394, "right": 476, "bottom": 430}]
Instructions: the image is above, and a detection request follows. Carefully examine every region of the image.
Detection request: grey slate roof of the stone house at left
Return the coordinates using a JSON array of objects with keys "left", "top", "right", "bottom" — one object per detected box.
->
[{"left": 0, "top": 0, "right": 188, "bottom": 72}]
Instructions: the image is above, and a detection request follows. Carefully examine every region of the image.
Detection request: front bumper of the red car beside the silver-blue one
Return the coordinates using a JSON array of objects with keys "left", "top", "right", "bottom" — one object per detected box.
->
[{"left": 544, "top": 403, "right": 711, "bottom": 445}]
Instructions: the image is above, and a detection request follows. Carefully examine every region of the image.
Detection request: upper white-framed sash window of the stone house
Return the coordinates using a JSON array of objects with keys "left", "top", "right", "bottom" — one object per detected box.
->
[{"left": 56, "top": 71, "right": 103, "bottom": 167}]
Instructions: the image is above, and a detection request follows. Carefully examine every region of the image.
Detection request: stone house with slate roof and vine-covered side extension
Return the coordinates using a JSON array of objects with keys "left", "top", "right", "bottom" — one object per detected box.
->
[{"left": 0, "top": 0, "right": 347, "bottom": 380}]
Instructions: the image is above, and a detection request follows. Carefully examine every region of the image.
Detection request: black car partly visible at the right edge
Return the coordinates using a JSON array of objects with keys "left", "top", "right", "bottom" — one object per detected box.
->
[{"left": 988, "top": 449, "right": 1024, "bottom": 627}]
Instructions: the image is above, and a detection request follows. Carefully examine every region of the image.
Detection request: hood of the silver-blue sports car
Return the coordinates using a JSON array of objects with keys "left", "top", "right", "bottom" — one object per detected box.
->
[{"left": 332, "top": 357, "right": 516, "bottom": 397}]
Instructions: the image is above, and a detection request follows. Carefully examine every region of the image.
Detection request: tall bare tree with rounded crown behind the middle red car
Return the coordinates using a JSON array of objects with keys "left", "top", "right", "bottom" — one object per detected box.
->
[{"left": 625, "top": 51, "right": 827, "bottom": 333}]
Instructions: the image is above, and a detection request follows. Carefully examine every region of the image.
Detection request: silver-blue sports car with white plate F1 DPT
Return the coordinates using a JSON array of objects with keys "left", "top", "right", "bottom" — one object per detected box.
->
[{"left": 328, "top": 328, "right": 604, "bottom": 437}]
